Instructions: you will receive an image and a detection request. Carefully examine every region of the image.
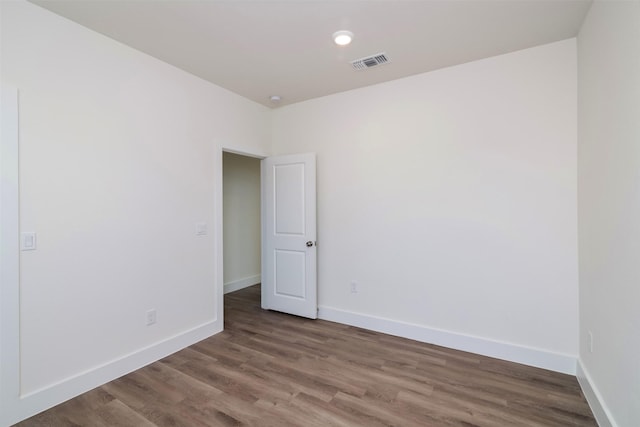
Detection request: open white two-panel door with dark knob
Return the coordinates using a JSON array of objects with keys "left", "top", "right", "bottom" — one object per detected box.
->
[{"left": 261, "top": 153, "right": 318, "bottom": 319}]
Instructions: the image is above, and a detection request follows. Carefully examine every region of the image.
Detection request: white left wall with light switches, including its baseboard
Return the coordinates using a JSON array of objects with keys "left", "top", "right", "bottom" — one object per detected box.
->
[{"left": 0, "top": 1, "right": 269, "bottom": 424}]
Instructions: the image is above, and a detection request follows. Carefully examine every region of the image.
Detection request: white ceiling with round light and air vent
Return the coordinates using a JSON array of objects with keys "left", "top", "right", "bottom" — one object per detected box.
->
[{"left": 31, "top": 0, "right": 591, "bottom": 107}]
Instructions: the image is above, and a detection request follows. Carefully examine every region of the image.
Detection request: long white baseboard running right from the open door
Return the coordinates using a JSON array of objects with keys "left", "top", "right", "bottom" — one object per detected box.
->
[{"left": 318, "top": 307, "right": 576, "bottom": 375}]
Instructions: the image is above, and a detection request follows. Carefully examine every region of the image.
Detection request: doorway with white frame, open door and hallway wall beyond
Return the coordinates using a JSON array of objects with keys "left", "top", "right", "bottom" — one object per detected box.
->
[{"left": 216, "top": 149, "right": 318, "bottom": 327}]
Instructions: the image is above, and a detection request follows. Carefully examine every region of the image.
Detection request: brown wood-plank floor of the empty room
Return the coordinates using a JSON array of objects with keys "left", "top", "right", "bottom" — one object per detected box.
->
[{"left": 18, "top": 286, "right": 597, "bottom": 427}]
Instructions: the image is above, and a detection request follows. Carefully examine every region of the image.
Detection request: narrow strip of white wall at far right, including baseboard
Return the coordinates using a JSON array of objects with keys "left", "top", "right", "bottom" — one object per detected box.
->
[{"left": 578, "top": 1, "right": 640, "bottom": 427}]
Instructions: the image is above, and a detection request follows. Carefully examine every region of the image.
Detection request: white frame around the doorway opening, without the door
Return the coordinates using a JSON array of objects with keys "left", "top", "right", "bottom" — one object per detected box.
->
[{"left": 214, "top": 144, "right": 269, "bottom": 320}]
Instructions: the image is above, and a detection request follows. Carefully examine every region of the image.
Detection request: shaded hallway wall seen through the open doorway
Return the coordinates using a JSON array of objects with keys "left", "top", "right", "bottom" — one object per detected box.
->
[{"left": 223, "top": 153, "right": 261, "bottom": 292}]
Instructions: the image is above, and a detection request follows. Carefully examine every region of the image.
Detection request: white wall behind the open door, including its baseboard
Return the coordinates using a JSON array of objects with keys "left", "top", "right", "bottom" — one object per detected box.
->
[{"left": 273, "top": 39, "right": 578, "bottom": 372}]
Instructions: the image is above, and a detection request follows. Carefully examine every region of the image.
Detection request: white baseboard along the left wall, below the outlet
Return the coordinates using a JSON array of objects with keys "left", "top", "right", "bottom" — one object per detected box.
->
[{"left": 0, "top": 320, "right": 222, "bottom": 426}]
